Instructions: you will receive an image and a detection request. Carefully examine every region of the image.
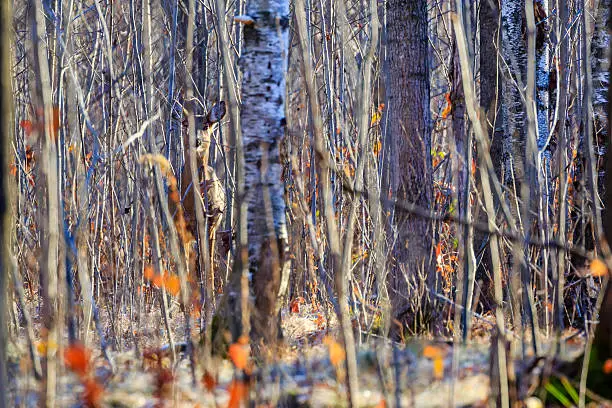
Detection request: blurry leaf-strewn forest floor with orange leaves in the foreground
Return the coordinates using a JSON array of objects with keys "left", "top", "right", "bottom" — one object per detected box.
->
[{"left": 3, "top": 305, "right": 596, "bottom": 408}]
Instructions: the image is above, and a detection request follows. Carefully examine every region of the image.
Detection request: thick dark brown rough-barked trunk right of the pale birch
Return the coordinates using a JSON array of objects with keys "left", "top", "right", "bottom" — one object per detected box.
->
[{"left": 385, "top": 0, "right": 435, "bottom": 331}]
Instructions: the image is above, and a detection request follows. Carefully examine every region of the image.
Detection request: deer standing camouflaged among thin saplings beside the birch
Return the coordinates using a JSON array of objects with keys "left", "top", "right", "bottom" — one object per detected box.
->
[{"left": 180, "top": 101, "right": 227, "bottom": 293}]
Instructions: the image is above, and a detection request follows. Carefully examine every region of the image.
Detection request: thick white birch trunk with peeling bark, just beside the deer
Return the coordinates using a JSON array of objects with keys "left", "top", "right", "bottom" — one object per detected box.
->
[{"left": 240, "top": 0, "right": 289, "bottom": 344}]
